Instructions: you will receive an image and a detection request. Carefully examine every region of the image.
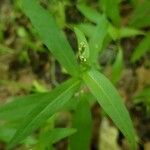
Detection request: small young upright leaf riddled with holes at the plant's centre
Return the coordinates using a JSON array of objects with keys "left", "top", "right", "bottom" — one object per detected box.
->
[{"left": 74, "top": 27, "right": 90, "bottom": 61}]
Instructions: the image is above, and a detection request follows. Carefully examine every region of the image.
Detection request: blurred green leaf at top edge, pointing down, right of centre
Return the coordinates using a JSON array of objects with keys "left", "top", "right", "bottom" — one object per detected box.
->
[{"left": 100, "top": 0, "right": 121, "bottom": 26}]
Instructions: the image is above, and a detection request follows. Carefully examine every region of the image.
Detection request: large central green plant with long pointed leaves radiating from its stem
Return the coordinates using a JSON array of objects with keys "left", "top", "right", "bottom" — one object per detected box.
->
[{"left": 0, "top": 0, "right": 137, "bottom": 150}]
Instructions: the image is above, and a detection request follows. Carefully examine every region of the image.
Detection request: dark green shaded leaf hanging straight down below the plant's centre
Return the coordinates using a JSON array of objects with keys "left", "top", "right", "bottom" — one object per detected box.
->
[{"left": 70, "top": 96, "right": 92, "bottom": 150}]
